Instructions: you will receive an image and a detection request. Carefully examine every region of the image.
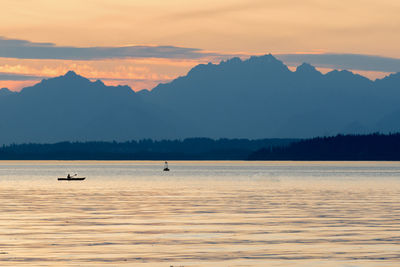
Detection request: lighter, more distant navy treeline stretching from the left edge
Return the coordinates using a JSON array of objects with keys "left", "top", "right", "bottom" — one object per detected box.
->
[{"left": 0, "top": 138, "right": 295, "bottom": 160}]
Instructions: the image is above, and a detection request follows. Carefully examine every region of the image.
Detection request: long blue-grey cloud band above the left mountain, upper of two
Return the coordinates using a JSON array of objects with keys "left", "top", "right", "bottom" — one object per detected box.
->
[{"left": 0, "top": 37, "right": 218, "bottom": 60}]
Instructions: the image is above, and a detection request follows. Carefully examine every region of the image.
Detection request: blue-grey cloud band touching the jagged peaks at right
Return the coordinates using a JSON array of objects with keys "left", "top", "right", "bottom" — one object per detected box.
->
[{"left": 276, "top": 53, "right": 400, "bottom": 72}]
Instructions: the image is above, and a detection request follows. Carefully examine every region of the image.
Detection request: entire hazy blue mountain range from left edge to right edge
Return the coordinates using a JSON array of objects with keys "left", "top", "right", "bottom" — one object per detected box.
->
[{"left": 0, "top": 55, "right": 400, "bottom": 146}]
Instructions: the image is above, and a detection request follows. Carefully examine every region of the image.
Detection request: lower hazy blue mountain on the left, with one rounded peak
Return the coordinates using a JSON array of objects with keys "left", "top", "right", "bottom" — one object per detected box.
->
[{"left": 0, "top": 71, "right": 175, "bottom": 143}]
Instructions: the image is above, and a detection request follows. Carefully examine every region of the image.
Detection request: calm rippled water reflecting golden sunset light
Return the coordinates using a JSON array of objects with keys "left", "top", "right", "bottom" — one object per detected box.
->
[{"left": 0, "top": 161, "right": 400, "bottom": 267}]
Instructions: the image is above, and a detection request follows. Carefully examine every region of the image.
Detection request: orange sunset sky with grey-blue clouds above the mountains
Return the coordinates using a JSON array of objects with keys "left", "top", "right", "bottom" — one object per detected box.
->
[{"left": 0, "top": 0, "right": 400, "bottom": 90}]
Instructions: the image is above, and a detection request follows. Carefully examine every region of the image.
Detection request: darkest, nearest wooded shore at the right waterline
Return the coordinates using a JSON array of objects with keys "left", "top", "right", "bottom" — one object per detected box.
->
[{"left": 248, "top": 133, "right": 400, "bottom": 161}]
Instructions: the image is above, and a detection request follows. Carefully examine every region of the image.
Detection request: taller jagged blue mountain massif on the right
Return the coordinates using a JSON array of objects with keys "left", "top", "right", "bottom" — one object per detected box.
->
[{"left": 151, "top": 55, "right": 400, "bottom": 138}]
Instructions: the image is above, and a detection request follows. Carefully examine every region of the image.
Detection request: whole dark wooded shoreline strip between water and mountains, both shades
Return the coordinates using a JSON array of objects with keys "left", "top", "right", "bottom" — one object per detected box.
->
[{"left": 0, "top": 133, "right": 400, "bottom": 161}]
